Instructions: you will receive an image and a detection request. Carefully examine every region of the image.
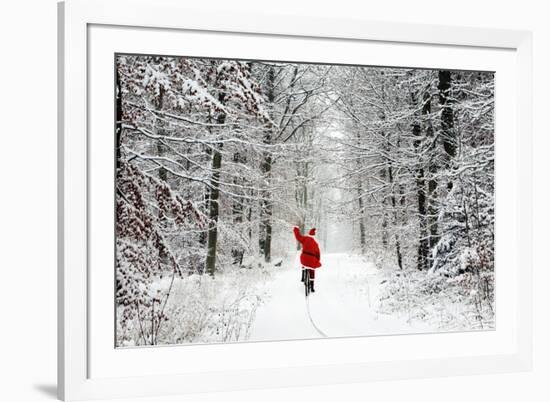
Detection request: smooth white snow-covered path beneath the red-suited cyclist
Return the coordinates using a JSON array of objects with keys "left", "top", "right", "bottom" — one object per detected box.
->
[{"left": 249, "top": 253, "right": 420, "bottom": 341}]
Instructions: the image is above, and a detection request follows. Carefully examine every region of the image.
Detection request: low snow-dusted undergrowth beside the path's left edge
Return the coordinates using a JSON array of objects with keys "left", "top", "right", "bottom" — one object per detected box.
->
[{"left": 117, "top": 260, "right": 270, "bottom": 346}]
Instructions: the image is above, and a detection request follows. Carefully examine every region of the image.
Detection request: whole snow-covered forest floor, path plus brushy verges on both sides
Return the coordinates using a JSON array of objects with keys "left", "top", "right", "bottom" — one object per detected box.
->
[{"left": 118, "top": 252, "right": 494, "bottom": 346}]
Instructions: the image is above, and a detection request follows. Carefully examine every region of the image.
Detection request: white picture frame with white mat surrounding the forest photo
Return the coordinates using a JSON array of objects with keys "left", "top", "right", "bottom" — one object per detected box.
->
[{"left": 58, "top": 0, "right": 532, "bottom": 400}]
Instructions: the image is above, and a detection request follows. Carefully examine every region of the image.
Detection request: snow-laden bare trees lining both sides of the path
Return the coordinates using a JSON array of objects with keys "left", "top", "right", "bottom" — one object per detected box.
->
[{"left": 115, "top": 55, "right": 494, "bottom": 346}]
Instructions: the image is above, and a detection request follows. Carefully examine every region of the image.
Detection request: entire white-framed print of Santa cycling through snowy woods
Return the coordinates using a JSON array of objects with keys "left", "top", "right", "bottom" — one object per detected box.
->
[{"left": 59, "top": 0, "right": 532, "bottom": 400}]
